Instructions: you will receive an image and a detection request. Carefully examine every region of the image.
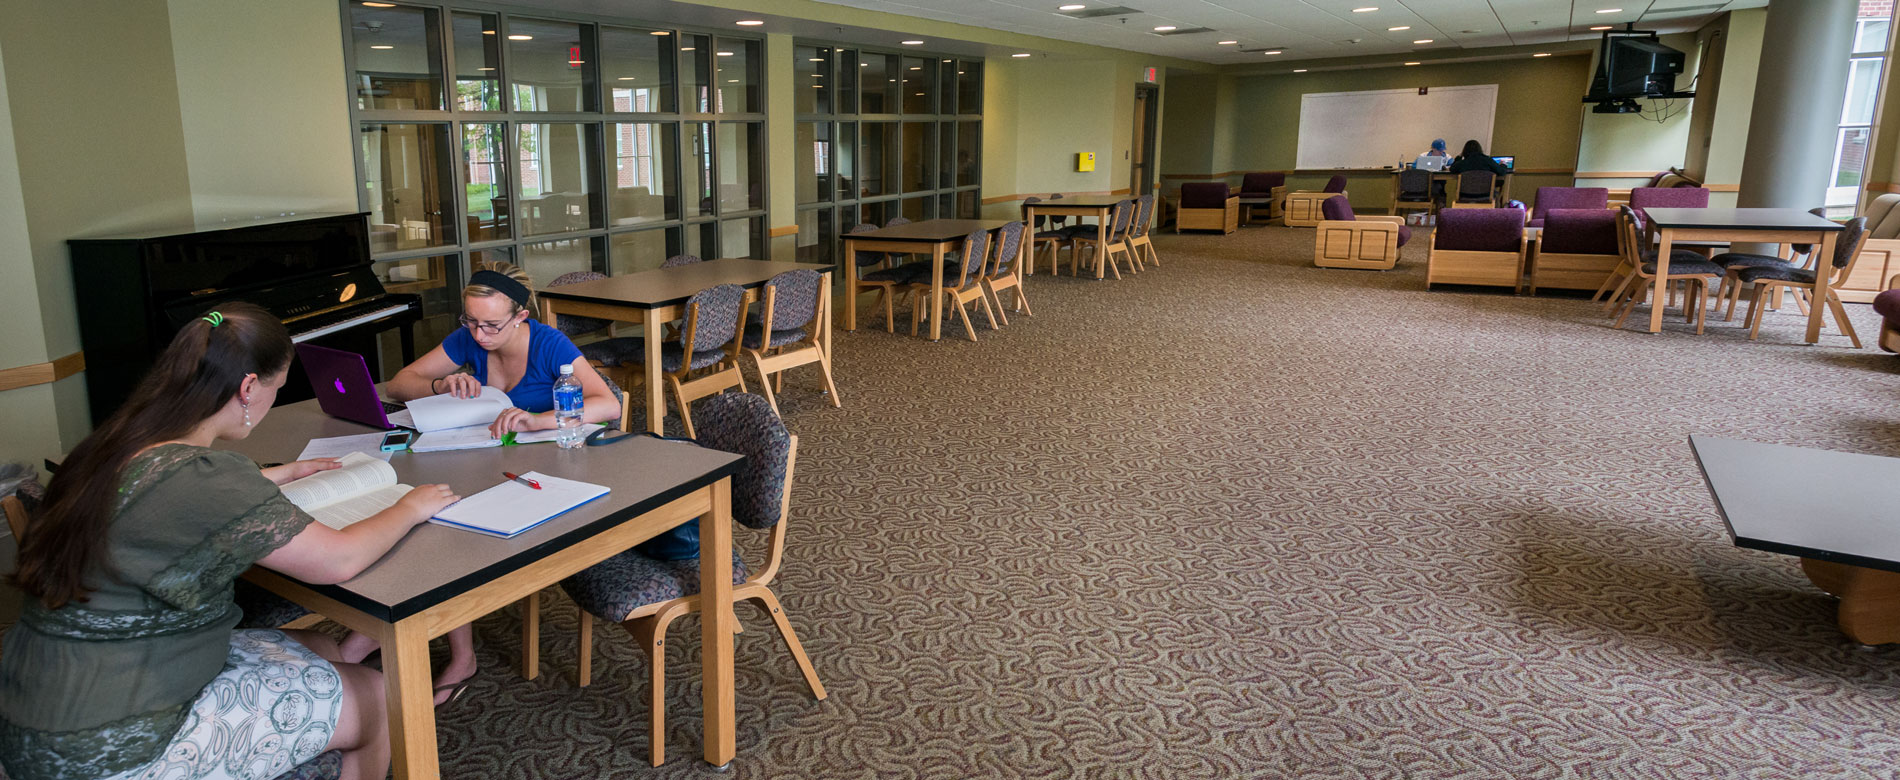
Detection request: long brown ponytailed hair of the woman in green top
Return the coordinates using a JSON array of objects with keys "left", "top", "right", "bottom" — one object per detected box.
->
[{"left": 11, "top": 304, "right": 293, "bottom": 609}]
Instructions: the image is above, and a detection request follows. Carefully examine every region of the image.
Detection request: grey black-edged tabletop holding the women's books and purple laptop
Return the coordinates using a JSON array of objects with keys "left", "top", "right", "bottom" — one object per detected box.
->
[{"left": 224, "top": 400, "right": 745, "bottom": 622}]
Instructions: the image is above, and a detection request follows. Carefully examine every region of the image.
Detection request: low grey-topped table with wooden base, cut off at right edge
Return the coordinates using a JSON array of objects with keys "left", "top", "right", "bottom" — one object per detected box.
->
[{"left": 1689, "top": 436, "right": 1900, "bottom": 645}]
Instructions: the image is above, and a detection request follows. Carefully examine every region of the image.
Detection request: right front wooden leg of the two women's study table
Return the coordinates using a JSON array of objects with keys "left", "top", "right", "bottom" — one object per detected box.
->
[{"left": 699, "top": 478, "right": 739, "bottom": 767}]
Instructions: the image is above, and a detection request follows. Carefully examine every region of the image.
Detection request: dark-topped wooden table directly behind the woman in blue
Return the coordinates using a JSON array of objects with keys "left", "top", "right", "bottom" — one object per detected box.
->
[{"left": 534, "top": 258, "right": 832, "bottom": 433}]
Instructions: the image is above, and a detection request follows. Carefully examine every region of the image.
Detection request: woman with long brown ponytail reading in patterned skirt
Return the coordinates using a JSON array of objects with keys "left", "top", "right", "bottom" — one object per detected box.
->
[{"left": 0, "top": 302, "right": 456, "bottom": 780}]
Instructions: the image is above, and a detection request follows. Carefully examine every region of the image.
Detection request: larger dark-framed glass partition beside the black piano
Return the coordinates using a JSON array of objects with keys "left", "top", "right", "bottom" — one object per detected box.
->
[{"left": 340, "top": 0, "right": 763, "bottom": 338}]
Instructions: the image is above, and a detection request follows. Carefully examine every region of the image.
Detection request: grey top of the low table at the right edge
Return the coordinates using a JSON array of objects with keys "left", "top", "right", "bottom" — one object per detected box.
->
[{"left": 1689, "top": 436, "right": 1900, "bottom": 571}]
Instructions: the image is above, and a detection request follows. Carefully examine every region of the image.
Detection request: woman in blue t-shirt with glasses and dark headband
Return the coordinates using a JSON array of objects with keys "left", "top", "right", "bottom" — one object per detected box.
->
[{"left": 342, "top": 264, "right": 619, "bottom": 704}]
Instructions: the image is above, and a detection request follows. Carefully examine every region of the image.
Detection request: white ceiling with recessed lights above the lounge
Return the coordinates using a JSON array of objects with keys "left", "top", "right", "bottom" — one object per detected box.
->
[{"left": 798, "top": 0, "right": 1769, "bottom": 65}]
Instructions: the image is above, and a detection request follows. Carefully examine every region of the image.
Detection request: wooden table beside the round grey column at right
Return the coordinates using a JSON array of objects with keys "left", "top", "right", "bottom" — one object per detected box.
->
[{"left": 1644, "top": 209, "right": 1843, "bottom": 344}]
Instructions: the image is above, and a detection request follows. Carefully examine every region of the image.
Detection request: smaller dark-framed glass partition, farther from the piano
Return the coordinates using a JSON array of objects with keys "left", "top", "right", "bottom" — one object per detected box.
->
[{"left": 792, "top": 42, "right": 982, "bottom": 264}]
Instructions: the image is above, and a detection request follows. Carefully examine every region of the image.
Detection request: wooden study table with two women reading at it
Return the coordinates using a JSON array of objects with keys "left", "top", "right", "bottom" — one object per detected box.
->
[{"left": 228, "top": 400, "right": 745, "bottom": 780}]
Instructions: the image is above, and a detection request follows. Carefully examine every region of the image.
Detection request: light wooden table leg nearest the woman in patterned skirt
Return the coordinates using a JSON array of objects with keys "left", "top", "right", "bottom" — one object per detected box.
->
[{"left": 380, "top": 618, "right": 438, "bottom": 780}]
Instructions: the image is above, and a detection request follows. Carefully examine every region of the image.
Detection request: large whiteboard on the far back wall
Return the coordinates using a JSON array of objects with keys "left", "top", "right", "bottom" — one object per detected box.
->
[{"left": 1298, "top": 84, "right": 1509, "bottom": 169}]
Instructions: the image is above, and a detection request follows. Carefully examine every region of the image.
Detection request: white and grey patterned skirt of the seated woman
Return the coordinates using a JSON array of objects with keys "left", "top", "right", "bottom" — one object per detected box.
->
[{"left": 106, "top": 628, "right": 344, "bottom": 780}]
